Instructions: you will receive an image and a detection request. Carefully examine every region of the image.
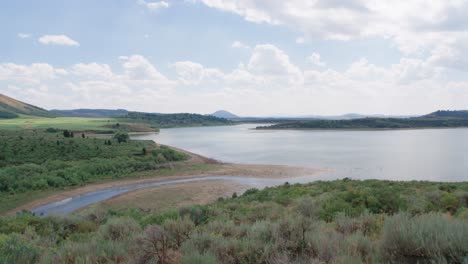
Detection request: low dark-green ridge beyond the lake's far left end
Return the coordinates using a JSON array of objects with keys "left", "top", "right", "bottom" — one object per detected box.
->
[{"left": 119, "top": 112, "right": 234, "bottom": 128}]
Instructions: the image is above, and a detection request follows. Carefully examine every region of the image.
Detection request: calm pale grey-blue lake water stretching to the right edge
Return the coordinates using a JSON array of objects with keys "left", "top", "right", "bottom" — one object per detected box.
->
[{"left": 132, "top": 124, "right": 468, "bottom": 181}]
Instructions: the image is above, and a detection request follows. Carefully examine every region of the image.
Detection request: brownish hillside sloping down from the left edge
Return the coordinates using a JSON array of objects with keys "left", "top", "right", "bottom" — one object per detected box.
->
[{"left": 0, "top": 94, "right": 56, "bottom": 118}]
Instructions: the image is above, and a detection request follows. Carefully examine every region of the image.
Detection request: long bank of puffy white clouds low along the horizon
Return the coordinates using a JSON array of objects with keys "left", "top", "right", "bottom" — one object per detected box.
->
[{"left": 0, "top": 44, "right": 468, "bottom": 115}]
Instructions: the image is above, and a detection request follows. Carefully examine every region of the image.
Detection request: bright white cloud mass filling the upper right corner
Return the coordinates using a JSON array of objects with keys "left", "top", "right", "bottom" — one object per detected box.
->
[{"left": 198, "top": 0, "right": 468, "bottom": 68}]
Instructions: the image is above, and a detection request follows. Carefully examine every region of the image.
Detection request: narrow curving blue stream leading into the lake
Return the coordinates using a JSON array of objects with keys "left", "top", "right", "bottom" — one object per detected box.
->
[{"left": 32, "top": 175, "right": 318, "bottom": 216}]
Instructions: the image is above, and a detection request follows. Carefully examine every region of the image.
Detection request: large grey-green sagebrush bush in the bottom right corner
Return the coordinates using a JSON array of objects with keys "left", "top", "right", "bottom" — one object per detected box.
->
[{"left": 381, "top": 213, "right": 468, "bottom": 263}]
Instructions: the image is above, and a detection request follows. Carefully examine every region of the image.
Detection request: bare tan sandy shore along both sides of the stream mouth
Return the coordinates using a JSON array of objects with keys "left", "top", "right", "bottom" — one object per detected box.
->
[{"left": 7, "top": 144, "right": 325, "bottom": 214}]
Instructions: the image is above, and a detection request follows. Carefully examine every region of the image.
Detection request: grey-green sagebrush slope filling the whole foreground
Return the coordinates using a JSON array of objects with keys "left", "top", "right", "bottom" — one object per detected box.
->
[{"left": 0, "top": 179, "right": 468, "bottom": 263}]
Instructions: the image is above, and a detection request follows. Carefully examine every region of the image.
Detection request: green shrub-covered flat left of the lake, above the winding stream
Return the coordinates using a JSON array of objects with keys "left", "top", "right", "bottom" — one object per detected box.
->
[{"left": 0, "top": 129, "right": 187, "bottom": 210}]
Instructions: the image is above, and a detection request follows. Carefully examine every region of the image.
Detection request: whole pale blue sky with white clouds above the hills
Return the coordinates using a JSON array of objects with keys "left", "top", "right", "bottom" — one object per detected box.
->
[{"left": 0, "top": 0, "right": 468, "bottom": 116}]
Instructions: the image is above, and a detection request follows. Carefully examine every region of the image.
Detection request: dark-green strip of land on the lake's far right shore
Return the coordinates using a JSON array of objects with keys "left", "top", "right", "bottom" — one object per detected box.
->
[{"left": 257, "top": 111, "right": 468, "bottom": 129}]
